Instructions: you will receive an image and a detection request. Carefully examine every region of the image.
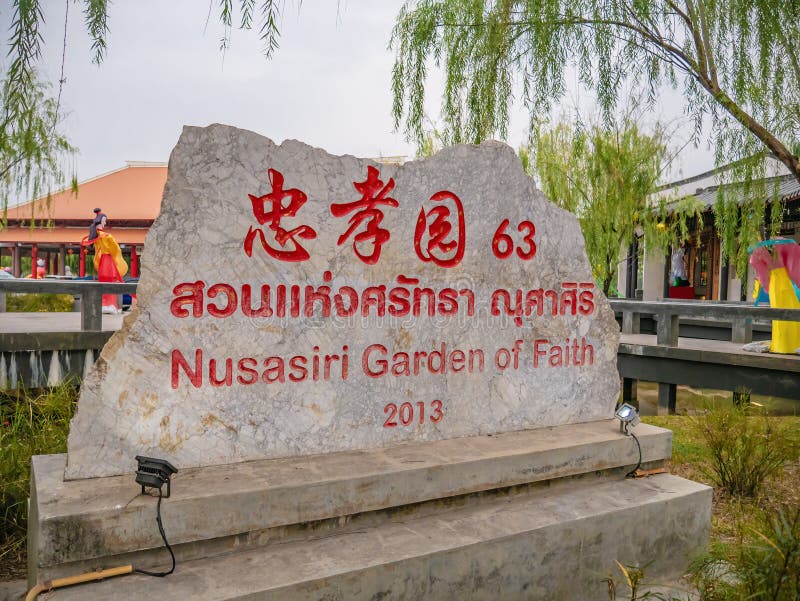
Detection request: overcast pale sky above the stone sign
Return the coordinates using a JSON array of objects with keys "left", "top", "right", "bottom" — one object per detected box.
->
[{"left": 23, "top": 0, "right": 713, "bottom": 190}]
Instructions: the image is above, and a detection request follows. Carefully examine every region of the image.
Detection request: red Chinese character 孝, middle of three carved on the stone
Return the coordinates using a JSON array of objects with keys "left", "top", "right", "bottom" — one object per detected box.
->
[{"left": 331, "top": 165, "right": 399, "bottom": 265}]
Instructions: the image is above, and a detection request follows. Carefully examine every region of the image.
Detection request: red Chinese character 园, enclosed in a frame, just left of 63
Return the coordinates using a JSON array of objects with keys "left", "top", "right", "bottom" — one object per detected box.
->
[{"left": 414, "top": 190, "right": 466, "bottom": 267}]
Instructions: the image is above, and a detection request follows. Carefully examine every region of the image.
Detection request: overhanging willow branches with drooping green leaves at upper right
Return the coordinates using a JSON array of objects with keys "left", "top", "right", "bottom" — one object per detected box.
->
[{"left": 392, "top": 0, "right": 800, "bottom": 274}]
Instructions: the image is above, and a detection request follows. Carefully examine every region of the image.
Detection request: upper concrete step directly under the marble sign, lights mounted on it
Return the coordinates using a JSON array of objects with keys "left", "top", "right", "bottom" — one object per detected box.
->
[{"left": 28, "top": 420, "right": 672, "bottom": 582}]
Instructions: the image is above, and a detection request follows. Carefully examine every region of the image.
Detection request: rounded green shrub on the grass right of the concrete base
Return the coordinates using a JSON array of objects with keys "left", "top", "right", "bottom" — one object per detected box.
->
[{"left": 694, "top": 406, "right": 789, "bottom": 496}]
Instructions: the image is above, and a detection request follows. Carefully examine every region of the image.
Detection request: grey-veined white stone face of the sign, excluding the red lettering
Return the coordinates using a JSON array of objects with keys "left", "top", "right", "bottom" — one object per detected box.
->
[{"left": 66, "top": 125, "right": 619, "bottom": 479}]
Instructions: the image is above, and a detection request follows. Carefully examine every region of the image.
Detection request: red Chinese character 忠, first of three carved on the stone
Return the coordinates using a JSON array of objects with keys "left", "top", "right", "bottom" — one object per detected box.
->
[{"left": 244, "top": 169, "right": 317, "bottom": 262}]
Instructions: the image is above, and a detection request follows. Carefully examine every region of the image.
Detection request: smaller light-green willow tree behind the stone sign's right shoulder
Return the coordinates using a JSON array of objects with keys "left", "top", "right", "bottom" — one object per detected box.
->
[{"left": 521, "top": 118, "right": 702, "bottom": 295}]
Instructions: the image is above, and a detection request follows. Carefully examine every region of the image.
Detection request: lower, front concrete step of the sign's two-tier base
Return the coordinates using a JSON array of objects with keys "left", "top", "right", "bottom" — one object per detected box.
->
[{"left": 40, "top": 474, "right": 711, "bottom": 601}]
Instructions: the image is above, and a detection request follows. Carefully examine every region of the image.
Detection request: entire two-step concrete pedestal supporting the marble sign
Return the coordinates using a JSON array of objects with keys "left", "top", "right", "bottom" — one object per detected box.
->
[{"left": 29, "top": 421, "right": 711, "bottom": 601}]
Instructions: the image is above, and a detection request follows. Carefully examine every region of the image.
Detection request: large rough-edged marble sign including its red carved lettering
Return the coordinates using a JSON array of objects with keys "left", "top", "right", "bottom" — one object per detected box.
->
[{"left": 67, "top": 125, "right": 619, "bottom": 479}]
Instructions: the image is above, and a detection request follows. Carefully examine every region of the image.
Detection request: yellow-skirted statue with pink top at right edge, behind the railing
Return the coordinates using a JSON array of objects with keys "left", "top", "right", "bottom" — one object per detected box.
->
[{"left": 750, "top": 238, "right": 800, "bottom": 354}]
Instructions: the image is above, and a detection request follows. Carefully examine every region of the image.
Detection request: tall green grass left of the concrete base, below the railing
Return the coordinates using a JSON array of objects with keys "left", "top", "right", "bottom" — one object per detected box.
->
[{"left": 0, "top": 383, "right": 78, "bottom": 580}]
